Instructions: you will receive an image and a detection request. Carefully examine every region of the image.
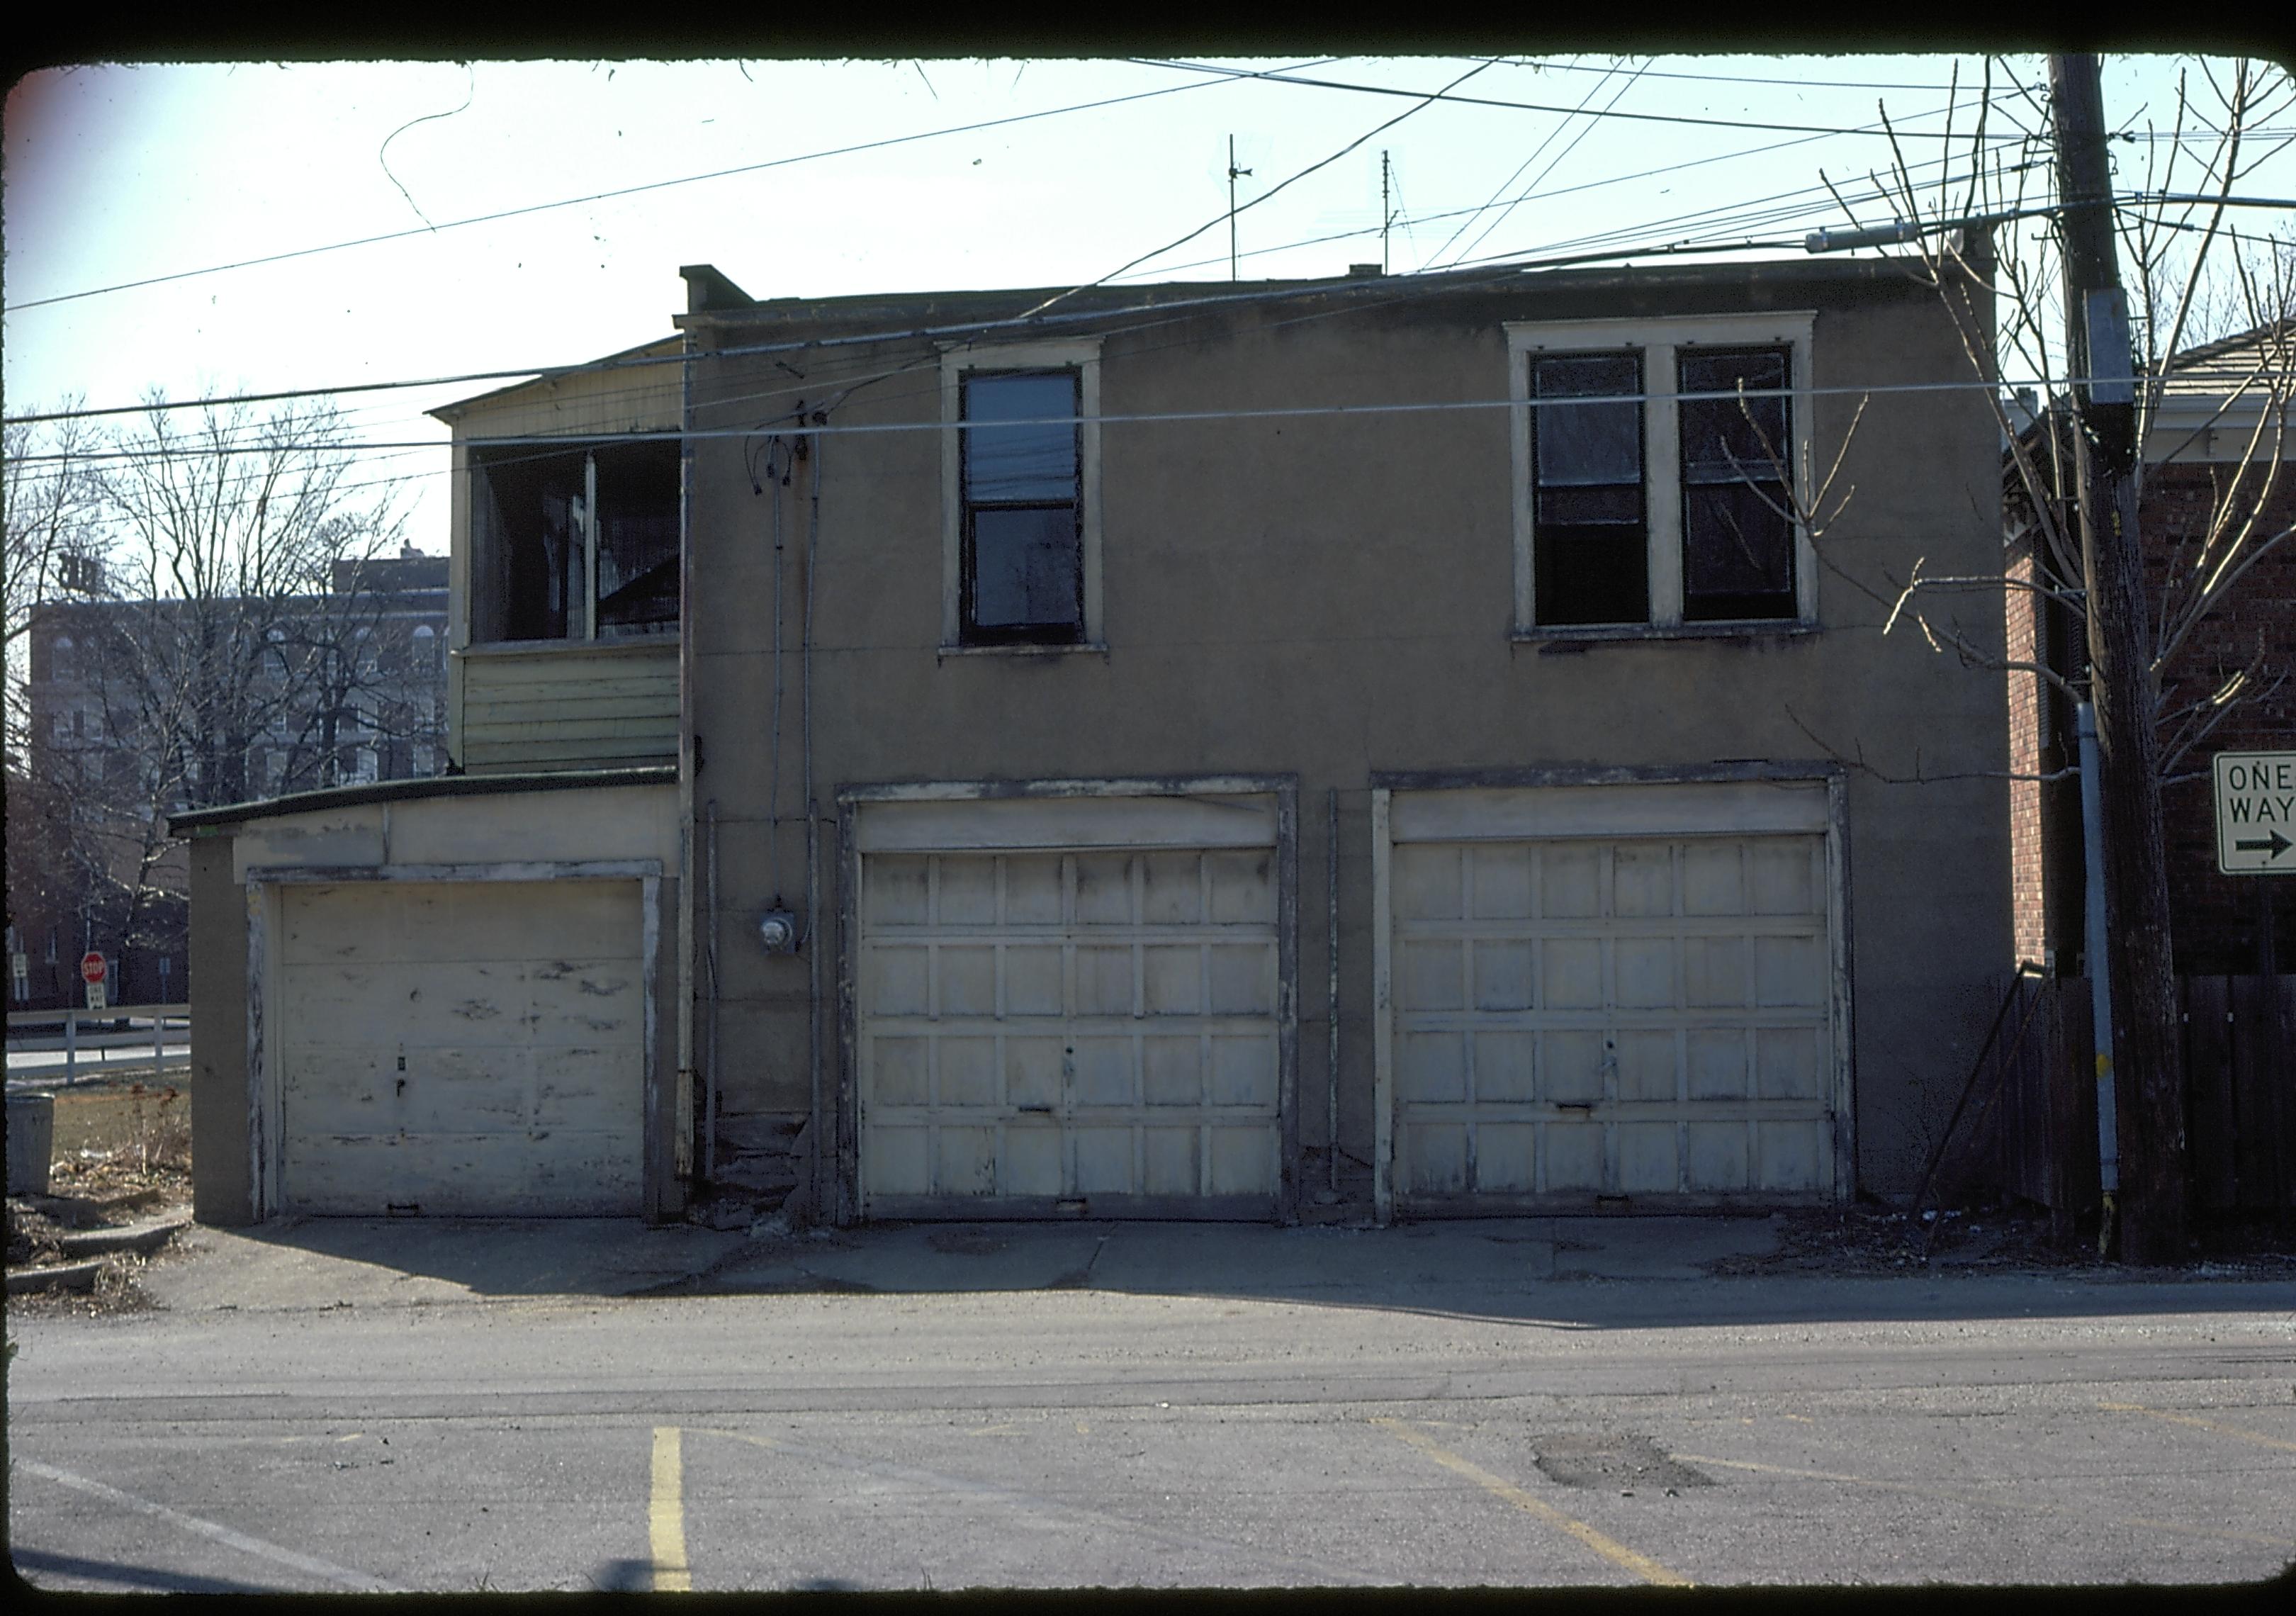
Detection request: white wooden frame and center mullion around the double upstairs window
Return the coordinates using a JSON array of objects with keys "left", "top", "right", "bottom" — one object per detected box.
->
[{"left": 1506, "top": 310, "right": 1818, "bottom": 641}]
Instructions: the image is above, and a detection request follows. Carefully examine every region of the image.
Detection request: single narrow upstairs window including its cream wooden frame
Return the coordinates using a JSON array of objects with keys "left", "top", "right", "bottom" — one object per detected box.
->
[{"left": 941, "top": 340, "right": 1100, "bottom": 647}]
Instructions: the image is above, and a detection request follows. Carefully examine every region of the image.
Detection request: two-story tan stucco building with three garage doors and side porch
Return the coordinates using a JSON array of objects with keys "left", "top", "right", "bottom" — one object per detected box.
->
[{"left": 174, "top": 249, "right": 2011, "bottom": 1221}]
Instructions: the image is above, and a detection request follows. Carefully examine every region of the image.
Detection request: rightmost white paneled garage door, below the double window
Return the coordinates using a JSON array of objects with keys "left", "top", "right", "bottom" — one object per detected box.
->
[{"left": 1387, "top": 782, "right": 1839, "bottom": 1212}]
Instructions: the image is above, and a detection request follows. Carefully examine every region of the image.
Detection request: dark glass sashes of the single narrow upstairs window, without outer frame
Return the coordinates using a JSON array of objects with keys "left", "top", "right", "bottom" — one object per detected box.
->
[{"left": 960, "top": 369, "right": 1084, "bottom": 645}]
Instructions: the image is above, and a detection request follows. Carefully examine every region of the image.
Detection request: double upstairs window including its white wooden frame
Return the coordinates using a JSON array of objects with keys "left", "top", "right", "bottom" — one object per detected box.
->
[{"left": 1506, "top": 312, "right": 1816, "bottom": 636}]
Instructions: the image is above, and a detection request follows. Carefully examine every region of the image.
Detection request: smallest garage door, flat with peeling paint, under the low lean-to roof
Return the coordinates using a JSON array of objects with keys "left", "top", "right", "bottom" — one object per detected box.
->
[{"left": 276, "top": 879, "right": 645, "bottom": 1216}]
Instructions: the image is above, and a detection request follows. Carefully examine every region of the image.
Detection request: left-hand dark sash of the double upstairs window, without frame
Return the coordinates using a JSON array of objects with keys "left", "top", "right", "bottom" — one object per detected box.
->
[{"left": 1531, "top": 354, "right": 1651, "bottom": 624}]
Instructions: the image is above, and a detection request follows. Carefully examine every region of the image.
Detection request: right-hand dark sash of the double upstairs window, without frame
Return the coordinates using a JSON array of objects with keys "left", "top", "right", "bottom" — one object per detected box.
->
[{"left": 1676, "top": 349, "right": 1796, "bottom": 622}]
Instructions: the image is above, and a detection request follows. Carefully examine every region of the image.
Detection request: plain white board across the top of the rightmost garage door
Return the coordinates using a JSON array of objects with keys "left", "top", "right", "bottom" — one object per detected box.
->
[{"left": 1389, "top": 780, "right": 1830, "bottom": 843}]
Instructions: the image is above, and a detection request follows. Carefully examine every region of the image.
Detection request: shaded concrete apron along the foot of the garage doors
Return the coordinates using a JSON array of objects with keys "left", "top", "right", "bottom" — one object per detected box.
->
[{"left": 145, "top": 1216, "right": 1779, "bottom": 1311}]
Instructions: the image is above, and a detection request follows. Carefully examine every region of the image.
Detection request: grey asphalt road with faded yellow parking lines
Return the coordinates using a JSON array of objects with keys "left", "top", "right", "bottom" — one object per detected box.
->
[{"left": 9, "top": 1230, "right": 2296, "bottom": 1590}]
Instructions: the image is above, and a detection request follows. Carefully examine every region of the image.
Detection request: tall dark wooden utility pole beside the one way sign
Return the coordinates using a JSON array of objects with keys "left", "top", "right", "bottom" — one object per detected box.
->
[{"left": 2048, "top": 55, "right": 2185, "bottom": 1262}]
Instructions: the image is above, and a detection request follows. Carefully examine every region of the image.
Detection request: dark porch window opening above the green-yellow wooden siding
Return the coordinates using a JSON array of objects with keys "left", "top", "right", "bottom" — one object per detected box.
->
[{"left": 471, "top": 443, "right": 680, "bottom": 643}]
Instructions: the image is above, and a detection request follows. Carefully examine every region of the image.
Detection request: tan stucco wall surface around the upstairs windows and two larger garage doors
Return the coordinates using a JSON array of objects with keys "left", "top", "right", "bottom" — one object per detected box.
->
[{"left": 687, "top": 271, "right": 2011, "bottom": 1191}]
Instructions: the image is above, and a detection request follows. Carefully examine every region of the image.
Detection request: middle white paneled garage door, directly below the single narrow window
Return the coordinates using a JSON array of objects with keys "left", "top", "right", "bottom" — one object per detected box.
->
[{"left": 854, "top": 797, "right": 1285, "bottom": 1216}]
